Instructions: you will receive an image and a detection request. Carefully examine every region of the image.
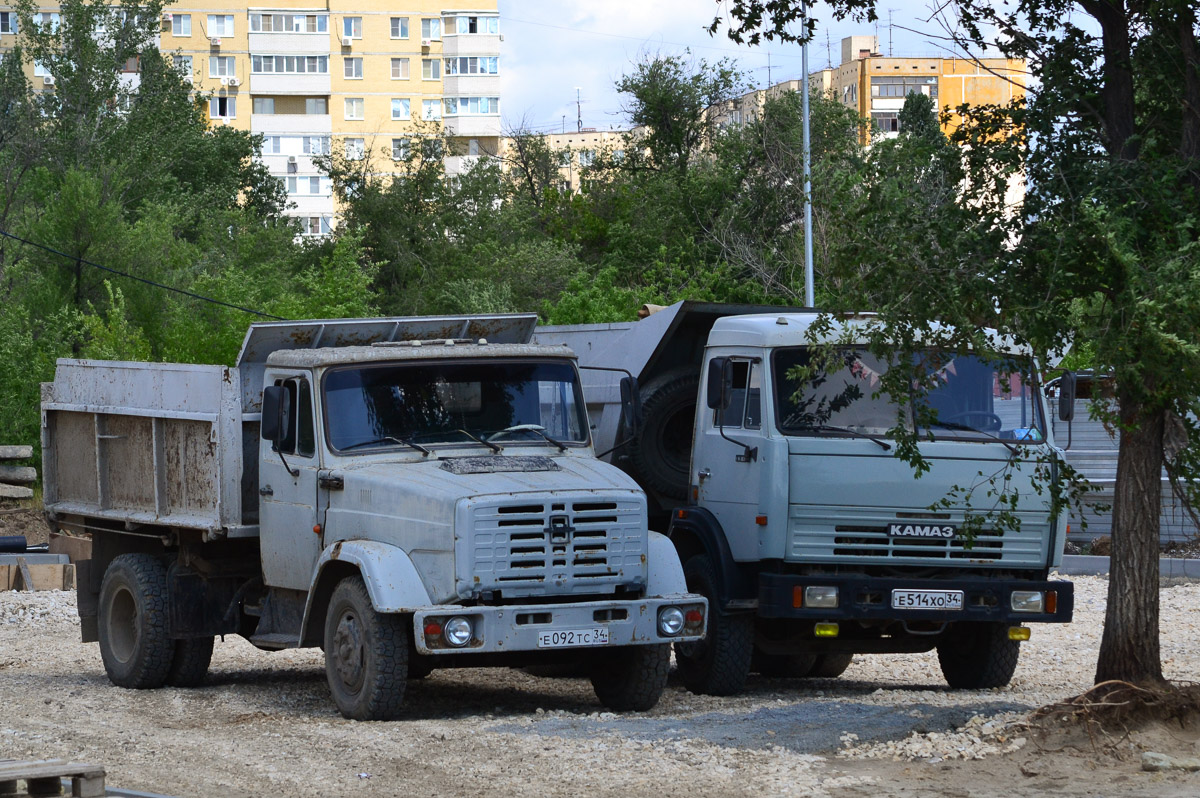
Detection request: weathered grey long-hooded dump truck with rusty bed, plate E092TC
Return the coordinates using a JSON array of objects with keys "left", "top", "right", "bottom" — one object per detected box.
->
[{"left": 42, "top": 314, "right": 707, "bottom": 720}]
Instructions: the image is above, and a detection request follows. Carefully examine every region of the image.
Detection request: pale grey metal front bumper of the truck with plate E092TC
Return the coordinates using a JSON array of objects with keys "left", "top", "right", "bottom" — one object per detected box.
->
[{"left": 413, "top": 593, "right": 708, "bottom": 655}]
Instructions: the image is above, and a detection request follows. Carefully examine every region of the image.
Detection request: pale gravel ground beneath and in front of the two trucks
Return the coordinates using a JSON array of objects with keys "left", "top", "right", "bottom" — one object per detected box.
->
[{"left": 0, "top": 577, "right": 1200, "bottom": 798}]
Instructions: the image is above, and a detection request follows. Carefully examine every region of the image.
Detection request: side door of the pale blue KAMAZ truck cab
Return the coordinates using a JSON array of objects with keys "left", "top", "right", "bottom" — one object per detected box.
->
[{"left": 692, "top": 359, "right": 763, "bottom": 559}]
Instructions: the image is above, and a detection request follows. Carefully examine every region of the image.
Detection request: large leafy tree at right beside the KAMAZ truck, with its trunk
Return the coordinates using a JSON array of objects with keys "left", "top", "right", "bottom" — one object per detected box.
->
[{"left": 714, "top": 0, "right": 1200, "bottom": 683}]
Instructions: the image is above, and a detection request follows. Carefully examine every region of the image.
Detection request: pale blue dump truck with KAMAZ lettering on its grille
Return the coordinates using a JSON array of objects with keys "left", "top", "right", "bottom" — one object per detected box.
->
[{"left": 536, "top": 302, "right": 1074, "bottom": 695}]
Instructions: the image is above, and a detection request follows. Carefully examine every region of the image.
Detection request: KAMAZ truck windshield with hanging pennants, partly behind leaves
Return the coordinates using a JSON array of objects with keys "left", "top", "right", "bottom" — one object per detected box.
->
[{"left": 773, "top": 348, "right": 1045, "bottom": 442}]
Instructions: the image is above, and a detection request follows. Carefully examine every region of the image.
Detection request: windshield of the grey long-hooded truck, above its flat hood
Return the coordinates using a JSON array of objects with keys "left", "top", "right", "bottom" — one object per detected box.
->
[{"left": 323, "top": 361, "right": 587, "bottom": 451}]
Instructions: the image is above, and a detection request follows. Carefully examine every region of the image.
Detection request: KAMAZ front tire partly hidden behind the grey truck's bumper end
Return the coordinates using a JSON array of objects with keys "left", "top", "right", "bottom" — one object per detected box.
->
[{"left": 676, "top": 554, "right": 754, "bottom": 696}]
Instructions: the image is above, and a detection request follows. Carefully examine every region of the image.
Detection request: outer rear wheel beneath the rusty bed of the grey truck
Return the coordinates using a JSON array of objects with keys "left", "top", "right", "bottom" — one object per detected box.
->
[{"left": 98, "top": 554, "right": 175, "bottom": 690}]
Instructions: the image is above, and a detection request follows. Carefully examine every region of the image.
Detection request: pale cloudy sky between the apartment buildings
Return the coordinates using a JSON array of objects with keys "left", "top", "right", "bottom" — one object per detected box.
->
[{"left": 499, "top": 0, "right": 998, "bottom": 132}]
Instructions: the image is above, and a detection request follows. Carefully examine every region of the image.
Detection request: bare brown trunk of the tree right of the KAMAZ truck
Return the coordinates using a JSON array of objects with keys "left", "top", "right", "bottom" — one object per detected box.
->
[{"left": 1096, "top": 396, "right": 1165, "bottom": 684}]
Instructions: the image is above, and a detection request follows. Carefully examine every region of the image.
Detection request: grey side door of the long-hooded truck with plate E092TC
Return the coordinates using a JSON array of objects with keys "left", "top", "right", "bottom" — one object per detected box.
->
[{"left": 258, "top": 374, "right": 320, "bottom": 590}]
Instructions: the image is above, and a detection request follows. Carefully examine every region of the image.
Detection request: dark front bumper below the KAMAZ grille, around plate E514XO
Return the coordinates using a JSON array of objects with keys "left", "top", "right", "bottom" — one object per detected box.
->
[{"left": 758, "top": 574, "right": 1075, "bottom": 623}]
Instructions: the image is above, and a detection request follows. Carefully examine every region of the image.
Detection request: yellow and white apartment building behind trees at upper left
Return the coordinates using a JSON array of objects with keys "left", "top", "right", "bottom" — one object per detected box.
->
[{"left": 0, "top": 0, "right": 502, "bottom": 235}]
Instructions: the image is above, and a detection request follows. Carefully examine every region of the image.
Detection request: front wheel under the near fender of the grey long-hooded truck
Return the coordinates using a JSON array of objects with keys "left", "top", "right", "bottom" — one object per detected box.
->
[{"left": 325, "top": 576, "right": 409, "bottom": 720}]
